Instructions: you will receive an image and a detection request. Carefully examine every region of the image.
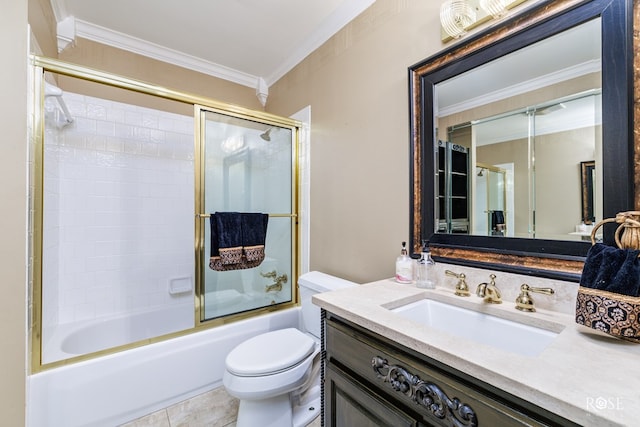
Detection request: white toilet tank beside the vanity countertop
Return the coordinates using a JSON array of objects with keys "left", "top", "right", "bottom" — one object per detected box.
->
[{"left": 298, "top": 271, "right": 357, "bottom": 338}]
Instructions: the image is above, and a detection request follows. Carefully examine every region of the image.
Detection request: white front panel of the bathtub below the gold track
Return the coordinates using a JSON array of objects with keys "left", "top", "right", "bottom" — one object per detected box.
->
[{"left": 27, "top": 308, "right": 300, "bottom": 427}]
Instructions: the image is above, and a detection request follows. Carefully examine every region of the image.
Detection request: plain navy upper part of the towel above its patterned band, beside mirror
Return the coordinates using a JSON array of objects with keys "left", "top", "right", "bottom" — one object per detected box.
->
[{"left": 580, "top": 243, "right": 640, "bottom": 297}]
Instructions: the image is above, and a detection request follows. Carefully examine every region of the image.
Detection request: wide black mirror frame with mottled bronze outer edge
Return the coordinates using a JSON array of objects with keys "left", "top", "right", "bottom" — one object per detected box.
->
[{"left": 409, "top": 0, "right": 634, "bottom": 281}]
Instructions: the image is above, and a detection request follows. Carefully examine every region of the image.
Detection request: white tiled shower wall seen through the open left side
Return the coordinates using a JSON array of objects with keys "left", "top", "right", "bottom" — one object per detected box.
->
[{"left": 45, "top": 93, "right": 194, "bottom": 323}]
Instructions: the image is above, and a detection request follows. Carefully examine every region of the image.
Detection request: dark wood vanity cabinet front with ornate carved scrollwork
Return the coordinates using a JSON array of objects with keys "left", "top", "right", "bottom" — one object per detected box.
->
[{"left": 323, "top": 312, "right": 577, "bottom": 427}]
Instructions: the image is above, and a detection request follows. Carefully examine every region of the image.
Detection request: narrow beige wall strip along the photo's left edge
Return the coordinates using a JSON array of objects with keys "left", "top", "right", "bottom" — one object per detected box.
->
[{"left": 0, "top": 0, "right": 28, "bottom": 426}]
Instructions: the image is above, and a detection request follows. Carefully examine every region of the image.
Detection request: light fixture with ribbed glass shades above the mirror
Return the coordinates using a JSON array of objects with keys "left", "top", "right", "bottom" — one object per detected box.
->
[{"left": 440, "top": 0, "right": 527, "bottom": 42}]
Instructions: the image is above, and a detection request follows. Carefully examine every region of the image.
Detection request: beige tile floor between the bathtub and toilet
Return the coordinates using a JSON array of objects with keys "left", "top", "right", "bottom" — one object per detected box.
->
[{"left": 121, "top": 387, "right": 320, "bottom": 427}]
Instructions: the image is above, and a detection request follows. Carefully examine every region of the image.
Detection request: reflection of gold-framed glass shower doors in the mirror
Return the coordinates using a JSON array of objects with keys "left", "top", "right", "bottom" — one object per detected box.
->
[{"left": 440, "top": 89, "right": 602, "bottom": 240}]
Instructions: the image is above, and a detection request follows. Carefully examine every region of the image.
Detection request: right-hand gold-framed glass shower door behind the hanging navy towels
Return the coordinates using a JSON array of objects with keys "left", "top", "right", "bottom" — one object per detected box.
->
[{"left": 200, "top": 111, "right": 296, "bottom": 320}]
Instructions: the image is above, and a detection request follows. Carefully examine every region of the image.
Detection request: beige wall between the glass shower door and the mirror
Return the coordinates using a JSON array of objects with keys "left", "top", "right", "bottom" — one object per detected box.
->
[{"left": 267, "top": 0, "right": 450, "bottom": 282}]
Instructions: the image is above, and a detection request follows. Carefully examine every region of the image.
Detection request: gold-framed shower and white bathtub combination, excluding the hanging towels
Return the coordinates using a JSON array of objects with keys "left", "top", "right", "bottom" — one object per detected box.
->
[{"left": 28, "top": 57, "right": 302, "bottom": 426}]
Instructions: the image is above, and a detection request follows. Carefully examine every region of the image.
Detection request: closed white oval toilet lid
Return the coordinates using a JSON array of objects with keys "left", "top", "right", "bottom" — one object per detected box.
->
[{"left": 226, "top": 328, "right": 315, "bottom": 376}]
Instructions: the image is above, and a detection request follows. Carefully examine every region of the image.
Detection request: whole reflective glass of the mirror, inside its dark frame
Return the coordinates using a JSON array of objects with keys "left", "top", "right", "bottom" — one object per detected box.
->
[{"left": 432, "top": 18, "right": 603, "bottom": 240}]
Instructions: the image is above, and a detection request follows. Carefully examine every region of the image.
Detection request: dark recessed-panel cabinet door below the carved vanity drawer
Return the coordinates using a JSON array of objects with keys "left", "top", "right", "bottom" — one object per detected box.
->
[{"left": 324, "top": 364, "right": 424, "bottom": 427}]
